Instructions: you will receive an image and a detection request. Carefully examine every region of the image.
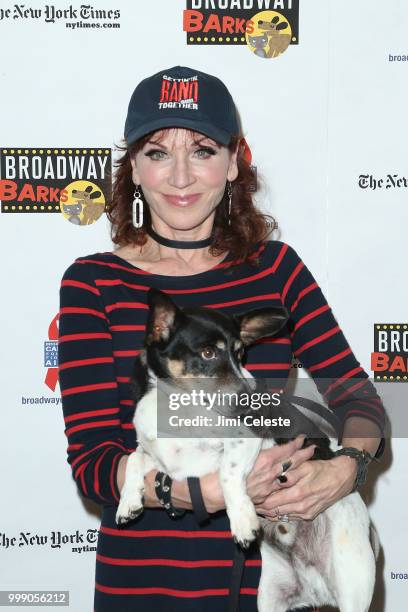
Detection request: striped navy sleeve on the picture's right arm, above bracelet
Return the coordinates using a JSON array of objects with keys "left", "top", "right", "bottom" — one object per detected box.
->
[{"left": 278, "top": 243, "right": 385, "bottom": 448}]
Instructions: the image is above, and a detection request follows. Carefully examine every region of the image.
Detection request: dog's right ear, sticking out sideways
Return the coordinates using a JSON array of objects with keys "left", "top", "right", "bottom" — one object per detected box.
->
[{"left": 235, "top": 306, "right": 289, "bottom": 345}]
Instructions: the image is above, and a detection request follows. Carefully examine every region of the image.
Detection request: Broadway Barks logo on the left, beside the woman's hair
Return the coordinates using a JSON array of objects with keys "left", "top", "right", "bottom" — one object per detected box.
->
[{"left": 0, "top": 148, "right": 111, "bottom": 225}]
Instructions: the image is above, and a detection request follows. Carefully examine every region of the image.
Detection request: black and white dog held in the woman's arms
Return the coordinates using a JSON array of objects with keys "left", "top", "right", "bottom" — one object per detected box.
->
[{"left": 116, "top": 289, "right": 378, "bottom": 612}]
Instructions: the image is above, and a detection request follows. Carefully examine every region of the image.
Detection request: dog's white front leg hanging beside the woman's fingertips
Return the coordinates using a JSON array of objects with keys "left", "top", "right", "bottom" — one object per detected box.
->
[{"left": 220, "top": 438, "right": 262, "bottom": 548}]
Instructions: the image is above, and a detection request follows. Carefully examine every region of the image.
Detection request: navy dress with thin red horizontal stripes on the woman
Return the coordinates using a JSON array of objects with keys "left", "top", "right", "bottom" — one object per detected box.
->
[{"left": 59, "top": 241, "right": 384, "bottom": 612}]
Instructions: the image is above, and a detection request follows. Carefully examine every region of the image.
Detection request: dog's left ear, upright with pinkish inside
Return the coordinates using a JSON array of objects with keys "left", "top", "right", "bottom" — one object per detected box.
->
[{"left": 146, "top": 289, "right": 181, "bottom": 344}]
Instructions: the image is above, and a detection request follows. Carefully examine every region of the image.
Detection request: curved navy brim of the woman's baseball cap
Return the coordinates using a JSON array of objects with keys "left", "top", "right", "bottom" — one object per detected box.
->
[{"left": 125, "top": 116, "right": 231, "bottom": 146}]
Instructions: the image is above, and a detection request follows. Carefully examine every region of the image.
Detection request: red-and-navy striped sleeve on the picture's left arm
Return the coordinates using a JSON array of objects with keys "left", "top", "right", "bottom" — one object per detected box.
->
[{"left": 58, "top": 263, "right": 130, "bottom": 505}]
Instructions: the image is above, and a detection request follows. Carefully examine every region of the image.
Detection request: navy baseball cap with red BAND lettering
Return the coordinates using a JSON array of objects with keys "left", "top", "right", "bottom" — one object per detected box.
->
[{"left": 125, "top": 66, "right": 241, "bottom": 146}]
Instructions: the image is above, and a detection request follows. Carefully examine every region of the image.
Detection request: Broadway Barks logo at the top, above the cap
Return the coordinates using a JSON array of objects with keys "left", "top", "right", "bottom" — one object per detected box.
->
[{"left": 183, "top": 0, "right": 299, "bottom": 58}]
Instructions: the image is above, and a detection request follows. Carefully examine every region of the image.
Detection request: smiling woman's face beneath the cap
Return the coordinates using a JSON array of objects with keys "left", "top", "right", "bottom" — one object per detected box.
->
[{"left": 131, "top": 128, "right": 238, "bottom": 230}]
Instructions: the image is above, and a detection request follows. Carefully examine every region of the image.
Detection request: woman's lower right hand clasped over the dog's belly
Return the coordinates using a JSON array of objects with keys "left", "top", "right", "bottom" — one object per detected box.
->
[{"left": 255, "top": 456, "right": 357, "bottom": 520}]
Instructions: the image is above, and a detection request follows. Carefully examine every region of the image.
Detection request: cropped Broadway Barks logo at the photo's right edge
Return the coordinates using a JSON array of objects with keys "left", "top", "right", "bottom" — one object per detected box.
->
[{"left": 371, "top": 323, "right": 408, "bottom": 382}]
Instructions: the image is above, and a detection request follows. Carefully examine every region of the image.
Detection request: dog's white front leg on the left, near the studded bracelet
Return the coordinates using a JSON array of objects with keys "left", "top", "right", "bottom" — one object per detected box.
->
[{"left": 116, "top": 446, "right": 148, "bottom": 525}]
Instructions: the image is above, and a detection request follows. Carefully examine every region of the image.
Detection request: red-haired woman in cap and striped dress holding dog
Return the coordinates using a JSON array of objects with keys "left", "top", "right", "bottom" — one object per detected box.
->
[{"left": 59, "top": 66, "right": 383, "bottom": 612}]
